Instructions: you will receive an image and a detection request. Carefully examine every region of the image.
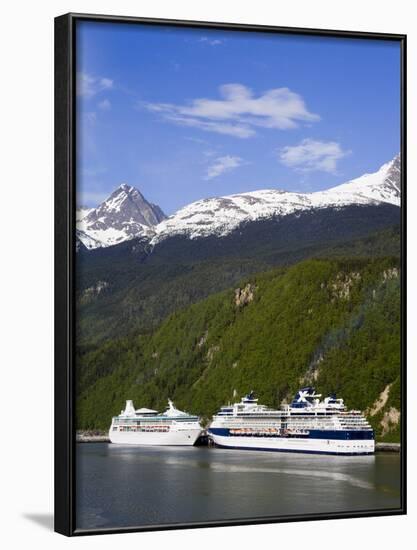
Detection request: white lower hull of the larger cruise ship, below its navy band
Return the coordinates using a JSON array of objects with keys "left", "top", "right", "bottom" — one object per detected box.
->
[{"left": 209, "top": 431, "right": 375, "bottom": 455}]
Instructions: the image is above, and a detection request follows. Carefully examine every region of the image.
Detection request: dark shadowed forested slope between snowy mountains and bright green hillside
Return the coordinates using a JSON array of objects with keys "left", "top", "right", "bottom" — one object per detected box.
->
[{"left": 77, "top": 205, "right": 399, "bottom": 347}]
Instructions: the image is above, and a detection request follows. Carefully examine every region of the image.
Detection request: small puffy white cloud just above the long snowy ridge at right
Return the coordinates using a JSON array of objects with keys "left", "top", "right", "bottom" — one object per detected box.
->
[{"left": 279, "top": 139, "right": 351, "bottom": 174}]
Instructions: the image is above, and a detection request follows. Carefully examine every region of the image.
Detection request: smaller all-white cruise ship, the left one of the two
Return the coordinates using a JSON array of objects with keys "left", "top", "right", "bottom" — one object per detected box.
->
[{"left": 109, "top": 400, "right": 201, "bottom": 445}]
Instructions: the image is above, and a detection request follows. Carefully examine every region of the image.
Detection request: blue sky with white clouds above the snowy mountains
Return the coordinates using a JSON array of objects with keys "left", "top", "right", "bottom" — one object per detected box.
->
[{"left": 77, "top": 22, "right": 400, "bottom": 214}]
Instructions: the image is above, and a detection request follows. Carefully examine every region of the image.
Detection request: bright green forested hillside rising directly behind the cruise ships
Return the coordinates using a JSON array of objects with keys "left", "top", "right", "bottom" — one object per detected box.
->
[{"left": 76, "top": 256, "right": 400, "bottom": 441}]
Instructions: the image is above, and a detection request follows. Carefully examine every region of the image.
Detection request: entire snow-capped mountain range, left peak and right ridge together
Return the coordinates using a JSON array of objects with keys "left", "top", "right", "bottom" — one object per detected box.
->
[{"left": 77, "top": 155, "right": 401, "bottom": 249}]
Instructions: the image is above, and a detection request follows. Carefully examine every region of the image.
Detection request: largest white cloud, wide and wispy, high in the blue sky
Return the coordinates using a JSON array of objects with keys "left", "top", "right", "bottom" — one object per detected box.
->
[{"left": 145, "top": 84, "right": 320, "bottom": 138}]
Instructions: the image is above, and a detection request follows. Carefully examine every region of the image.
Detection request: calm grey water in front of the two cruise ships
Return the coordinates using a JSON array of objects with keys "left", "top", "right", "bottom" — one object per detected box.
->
[{"left": 77, "top": 443, "right": 400, "bottom": 529}]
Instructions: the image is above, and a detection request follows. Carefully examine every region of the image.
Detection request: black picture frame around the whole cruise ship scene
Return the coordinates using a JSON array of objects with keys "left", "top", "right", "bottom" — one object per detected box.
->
[{"left": 55, "top": 13, "right": 407, "bottom": 536}]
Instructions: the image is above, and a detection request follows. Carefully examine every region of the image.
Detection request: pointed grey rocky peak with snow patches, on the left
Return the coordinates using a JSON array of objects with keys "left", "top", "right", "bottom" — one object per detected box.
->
[{"left": 77, "top": 183, "right": 165, "bottom": 249}]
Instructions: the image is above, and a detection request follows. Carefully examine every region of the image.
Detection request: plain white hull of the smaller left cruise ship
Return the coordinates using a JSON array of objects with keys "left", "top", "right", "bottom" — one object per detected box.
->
[{"left": 109, "top": 429, "right": 201, "bottom": 446}]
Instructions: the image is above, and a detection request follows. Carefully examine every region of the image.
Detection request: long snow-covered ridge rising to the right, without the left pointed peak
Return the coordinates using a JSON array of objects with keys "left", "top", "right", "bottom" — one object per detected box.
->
[{"left": 151, "top": 155, "right": 401, "bottom": 244}]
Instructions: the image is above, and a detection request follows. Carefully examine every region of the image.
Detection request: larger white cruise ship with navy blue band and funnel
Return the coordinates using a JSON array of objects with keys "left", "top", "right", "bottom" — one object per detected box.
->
[{"left": 208, "top": 387, "right": 375, "bottom": 455}]
